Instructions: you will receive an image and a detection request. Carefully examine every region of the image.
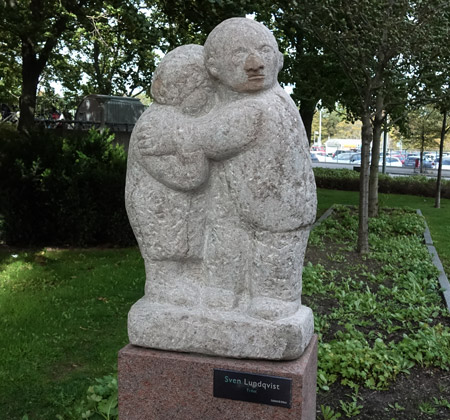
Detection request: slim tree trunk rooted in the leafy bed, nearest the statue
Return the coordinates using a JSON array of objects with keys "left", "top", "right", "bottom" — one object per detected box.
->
[{"left": 357, "top": 112, "right": 372, "bottom": 254}]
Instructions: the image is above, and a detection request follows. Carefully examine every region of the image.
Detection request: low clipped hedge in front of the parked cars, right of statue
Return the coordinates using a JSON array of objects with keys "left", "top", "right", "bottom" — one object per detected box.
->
[{"left": 314, "top": 168, "right": 450, "bottom": 198}]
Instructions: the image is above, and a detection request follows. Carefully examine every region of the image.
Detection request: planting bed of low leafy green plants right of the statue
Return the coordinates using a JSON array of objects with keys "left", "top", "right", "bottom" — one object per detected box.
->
[{"left": 303, "top": 207, "right": 450, "bottom": 420}]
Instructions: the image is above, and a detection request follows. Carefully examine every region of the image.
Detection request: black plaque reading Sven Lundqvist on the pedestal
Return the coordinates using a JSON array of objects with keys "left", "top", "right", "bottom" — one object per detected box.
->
[{"left": 214, "top": 369, "right": 292, "bottom": 408}]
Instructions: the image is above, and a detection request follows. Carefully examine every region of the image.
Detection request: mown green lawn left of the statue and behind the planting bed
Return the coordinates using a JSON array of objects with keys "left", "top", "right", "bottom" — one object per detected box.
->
[{"left": 0, "top": 190, "right": 450, "bottom": 420}]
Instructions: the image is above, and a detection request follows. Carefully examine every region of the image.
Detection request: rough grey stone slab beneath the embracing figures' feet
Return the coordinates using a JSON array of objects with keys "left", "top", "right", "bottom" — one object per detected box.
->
[{"left": 128, "top": 297, "right": 314, "bottom": 360}]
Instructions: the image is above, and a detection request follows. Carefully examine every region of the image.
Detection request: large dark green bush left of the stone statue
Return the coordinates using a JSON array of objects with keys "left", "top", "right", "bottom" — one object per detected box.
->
[{"left": 0, "top": 126, "right": 135, "bottom": 246}]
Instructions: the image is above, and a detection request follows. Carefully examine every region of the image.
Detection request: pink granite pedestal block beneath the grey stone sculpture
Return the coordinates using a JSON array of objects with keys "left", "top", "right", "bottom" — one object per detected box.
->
[{"left": 119, "top": 336, "right": 317, "bottom": 420}]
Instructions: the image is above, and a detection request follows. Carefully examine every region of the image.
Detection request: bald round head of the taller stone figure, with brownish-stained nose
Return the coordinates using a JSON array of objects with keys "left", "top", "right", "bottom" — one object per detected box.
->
[{"left": 205, "top": 18, "right": 283, "bottom": 92}]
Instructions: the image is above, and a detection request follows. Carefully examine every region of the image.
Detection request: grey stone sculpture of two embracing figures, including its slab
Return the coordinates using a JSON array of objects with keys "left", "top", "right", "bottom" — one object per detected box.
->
[{"left": 126, "top": 18, "right": 316, "bottom": 359}]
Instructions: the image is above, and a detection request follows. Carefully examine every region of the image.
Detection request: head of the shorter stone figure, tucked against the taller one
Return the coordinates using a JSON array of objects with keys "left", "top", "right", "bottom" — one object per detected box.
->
[{"left": 151, "top": 44, "right": 213, "bottom": 115}]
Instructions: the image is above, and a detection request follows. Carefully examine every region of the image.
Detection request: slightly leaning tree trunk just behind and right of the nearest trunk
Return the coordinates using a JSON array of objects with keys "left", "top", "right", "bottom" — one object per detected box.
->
[{"left": 369, "top": 93, "right": 384, "bottom": 217}]
